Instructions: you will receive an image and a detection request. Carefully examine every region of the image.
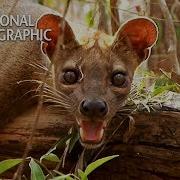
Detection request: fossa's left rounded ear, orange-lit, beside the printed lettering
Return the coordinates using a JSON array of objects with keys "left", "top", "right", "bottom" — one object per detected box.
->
[{"left": 36, "top": 14, "right": 76, "bottom": 57}]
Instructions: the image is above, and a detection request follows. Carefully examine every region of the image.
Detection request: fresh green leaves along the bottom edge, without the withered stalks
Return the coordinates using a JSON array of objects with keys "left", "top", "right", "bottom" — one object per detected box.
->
[{"left": 0, "top": 154, "right": 118, "bottom": 180}]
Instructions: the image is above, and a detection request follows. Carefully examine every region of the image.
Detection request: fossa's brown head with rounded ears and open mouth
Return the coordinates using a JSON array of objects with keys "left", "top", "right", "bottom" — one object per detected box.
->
[{"left": 37, "top": 14, "right": 158, "bottom": 148}]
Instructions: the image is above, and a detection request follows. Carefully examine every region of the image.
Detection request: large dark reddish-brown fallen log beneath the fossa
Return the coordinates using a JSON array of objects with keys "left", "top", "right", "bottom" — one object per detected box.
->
[{"left": 0, "top": 107, "right": 180, "bottom": 180}]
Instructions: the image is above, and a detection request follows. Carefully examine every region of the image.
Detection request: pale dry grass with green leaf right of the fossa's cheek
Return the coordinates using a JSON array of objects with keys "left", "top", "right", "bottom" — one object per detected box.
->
[{"left": 127, "top": 71, "right": 180, "bottom": 112}]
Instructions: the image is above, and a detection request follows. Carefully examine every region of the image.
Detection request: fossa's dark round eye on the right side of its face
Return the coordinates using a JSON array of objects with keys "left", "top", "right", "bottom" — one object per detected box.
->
[{"left": 111, "top": 72, "right": 126, "bottom": 87}]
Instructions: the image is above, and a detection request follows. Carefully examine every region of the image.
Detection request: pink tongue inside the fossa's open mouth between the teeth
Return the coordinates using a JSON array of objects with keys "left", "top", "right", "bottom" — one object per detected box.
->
[{"left": 80, "top": 121, "right": 104, "bottom": 143}]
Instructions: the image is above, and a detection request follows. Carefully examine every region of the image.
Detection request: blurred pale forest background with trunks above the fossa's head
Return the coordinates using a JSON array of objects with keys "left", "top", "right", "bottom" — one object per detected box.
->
[{"left": 36, "top": 0, "right": 180, "bottom": 76}]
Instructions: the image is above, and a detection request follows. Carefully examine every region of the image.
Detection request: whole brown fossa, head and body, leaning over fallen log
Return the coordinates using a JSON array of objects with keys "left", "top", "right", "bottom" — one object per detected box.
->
[{"left": 0, "top": 0, "right": 157, "bottom": 147}]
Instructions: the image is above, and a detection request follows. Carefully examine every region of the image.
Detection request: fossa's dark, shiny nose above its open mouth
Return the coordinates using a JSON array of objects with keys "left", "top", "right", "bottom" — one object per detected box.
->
[{"left": 80, "top": 99, "right": 108, "bottom": 117}]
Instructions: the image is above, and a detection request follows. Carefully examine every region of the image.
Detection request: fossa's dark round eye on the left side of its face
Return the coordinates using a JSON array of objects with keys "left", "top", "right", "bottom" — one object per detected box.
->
[{"left": 63, "top": 69, "right": 80, "bottom": 84}]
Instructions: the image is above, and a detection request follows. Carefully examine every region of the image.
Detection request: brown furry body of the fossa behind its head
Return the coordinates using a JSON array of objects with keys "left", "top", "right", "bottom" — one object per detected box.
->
[{"left": 0, "top": 0, "right": 52, "bottom": 124}]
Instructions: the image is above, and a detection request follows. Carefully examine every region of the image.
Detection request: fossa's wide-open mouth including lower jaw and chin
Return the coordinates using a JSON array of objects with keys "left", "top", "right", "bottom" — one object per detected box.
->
[{"left": 78, "top": 121, "right": 107, "bottom": 148}]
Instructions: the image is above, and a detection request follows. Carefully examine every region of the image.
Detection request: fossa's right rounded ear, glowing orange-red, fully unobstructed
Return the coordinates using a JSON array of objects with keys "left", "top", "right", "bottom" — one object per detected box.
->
[{"left": 116, "top": 17, "right": 158, "bottom": 61}]
